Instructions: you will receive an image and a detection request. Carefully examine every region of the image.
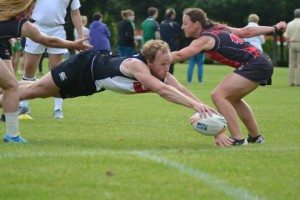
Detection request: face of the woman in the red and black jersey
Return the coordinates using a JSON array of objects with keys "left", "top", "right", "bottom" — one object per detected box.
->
[{"left": 181, "top": 14, "right": 200, "bottom": 38}]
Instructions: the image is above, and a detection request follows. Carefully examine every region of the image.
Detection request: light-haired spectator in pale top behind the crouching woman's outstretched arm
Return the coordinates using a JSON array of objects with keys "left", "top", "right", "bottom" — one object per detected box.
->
[{"left": 244, "top": 14, "right": 265, "bottom": 51}]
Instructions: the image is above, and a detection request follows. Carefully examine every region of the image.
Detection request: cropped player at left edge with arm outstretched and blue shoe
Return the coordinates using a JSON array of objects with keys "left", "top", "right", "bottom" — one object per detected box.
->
[{"left": 0, "top": 0, "right": 91, "bottom": 143}]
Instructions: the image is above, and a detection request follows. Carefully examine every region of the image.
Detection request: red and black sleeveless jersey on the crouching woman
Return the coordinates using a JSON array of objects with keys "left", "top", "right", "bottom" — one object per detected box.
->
[{"left": 200, "top": 24, "right": 263, "bottom": 68}]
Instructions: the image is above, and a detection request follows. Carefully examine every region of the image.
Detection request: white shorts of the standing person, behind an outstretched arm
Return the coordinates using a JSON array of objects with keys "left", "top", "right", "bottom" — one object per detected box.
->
[{"left": 25, "top": 23, "right": 68, "bottom": 54}]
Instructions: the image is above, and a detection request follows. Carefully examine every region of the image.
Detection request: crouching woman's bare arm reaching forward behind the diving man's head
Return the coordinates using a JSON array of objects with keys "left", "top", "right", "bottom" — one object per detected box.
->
[{"left": 171, "top": 36, "right": 215, "bottom": 63}]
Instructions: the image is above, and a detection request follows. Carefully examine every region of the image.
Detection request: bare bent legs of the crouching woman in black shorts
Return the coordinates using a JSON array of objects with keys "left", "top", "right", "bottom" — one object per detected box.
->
[{"left": 211, "top": 72, "right": 259, "bottom": 143}]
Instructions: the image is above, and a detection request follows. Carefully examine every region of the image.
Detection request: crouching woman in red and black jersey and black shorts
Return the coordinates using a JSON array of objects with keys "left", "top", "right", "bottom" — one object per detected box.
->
[{"left": 171, "top": 8, "right": 286, "bottom": 146}]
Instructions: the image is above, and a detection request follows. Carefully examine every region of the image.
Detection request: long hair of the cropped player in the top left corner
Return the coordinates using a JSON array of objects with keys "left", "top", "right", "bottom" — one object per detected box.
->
[{"left": 0, "top": 0, "right": 36, "bottom": 19}]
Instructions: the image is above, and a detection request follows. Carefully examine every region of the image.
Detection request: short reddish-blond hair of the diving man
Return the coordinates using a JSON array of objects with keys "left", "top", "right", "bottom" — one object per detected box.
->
[{"left": 141, "top": 40, "right": 170, "bottom": 61}]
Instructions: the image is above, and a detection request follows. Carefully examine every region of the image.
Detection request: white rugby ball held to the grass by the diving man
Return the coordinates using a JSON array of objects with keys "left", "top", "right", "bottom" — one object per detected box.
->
[{"left": 191, "top": 112, "right": 227, "bottom": 136}]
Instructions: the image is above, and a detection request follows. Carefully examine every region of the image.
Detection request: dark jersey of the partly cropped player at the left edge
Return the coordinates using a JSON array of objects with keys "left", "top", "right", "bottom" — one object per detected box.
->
[{"left": 0, "top": 16, "right": 28, "bottom": 40}]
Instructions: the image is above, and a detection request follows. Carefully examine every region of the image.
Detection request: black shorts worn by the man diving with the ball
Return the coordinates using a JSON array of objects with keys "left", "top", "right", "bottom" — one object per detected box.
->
[{"left": 51, "top": 51, "right": 99, "bottom": 99}]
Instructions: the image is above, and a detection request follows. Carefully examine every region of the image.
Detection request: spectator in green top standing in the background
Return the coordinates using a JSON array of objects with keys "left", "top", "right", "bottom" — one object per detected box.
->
[{"left": 142, "top": 7, "right": 160, "bottom": 44}]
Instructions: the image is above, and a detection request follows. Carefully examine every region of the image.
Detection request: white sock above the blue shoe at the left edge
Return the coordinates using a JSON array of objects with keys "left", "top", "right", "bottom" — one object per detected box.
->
[{"left": 4, "top": 111, "right": 19, "bottom": 137}]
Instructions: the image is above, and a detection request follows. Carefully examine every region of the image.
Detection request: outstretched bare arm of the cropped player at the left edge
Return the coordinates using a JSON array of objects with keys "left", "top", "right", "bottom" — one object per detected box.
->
[{"left": 21, "top": 21, "right": 92, "bottom": 51}]
